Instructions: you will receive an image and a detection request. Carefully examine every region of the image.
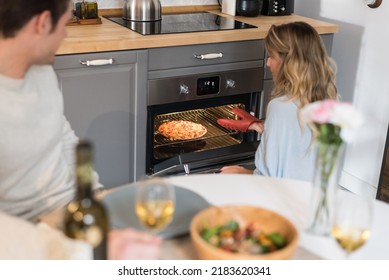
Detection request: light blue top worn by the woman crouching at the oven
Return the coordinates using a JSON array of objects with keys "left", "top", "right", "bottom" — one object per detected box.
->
[{"left": 254, "top": 97, "right": 315, "bottom": 181}]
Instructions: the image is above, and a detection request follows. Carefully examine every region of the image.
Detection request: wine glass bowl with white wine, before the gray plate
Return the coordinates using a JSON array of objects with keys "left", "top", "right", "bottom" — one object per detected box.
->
[{"left": 135, "top": 178, "right": 175, "bottom": 234}]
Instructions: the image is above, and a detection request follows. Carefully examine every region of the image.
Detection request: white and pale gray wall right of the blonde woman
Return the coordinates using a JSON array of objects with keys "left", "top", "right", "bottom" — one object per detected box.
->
[{"left": 295, "top": 0, "right": 389, "bottom": 197}]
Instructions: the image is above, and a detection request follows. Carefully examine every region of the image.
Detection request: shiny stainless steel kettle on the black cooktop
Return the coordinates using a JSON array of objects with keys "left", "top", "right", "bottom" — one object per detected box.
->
[{"left": 123, "top": 0, "right": 162, "bottom": 21}]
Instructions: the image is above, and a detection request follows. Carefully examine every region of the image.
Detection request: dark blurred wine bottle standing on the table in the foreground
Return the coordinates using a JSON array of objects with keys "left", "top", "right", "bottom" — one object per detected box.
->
[{"left": 64, "top": 141, "right": 108, "bottom": 260}]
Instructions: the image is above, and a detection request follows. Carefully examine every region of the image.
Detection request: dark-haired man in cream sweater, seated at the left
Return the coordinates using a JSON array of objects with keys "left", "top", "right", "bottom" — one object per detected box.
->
[{"left": 0, "top": 0, "right": 161, "bottom": 259}]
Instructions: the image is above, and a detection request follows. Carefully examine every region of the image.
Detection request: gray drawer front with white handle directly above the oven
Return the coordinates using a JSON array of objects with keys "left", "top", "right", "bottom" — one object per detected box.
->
[{"left": 149, "top": 40, "right": 265, "bottom": 71}]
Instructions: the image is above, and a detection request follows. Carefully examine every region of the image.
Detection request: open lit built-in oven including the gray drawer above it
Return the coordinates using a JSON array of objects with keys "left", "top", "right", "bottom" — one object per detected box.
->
[{"left": 146, "top": 40, "right": 264, "bottom": 176}]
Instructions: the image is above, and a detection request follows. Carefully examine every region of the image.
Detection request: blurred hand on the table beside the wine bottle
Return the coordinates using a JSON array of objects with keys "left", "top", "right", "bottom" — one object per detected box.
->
[{"left": 108, "top": 229, "right": 162, "bottom": 260}]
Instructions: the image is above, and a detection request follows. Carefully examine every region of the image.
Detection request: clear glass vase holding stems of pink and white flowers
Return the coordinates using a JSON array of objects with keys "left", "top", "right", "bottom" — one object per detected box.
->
[{"left": 308, "top": 142, "right": 344, "bottom": 236}]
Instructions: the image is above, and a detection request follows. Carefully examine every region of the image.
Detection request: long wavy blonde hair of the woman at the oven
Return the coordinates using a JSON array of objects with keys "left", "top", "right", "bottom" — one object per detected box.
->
[{"left": 265, "top": 22, "right": 338, "bottom": 107}]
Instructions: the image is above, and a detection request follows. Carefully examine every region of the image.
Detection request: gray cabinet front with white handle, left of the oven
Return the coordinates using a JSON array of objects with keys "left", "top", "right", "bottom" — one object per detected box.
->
[{"left": 54, "top": 50, "right": 147, "bottom": 188}]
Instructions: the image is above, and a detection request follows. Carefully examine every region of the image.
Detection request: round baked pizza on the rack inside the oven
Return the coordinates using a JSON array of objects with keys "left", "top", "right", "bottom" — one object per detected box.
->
[{"left": 158, "top": 120, "right": 207, "bottom": 140}]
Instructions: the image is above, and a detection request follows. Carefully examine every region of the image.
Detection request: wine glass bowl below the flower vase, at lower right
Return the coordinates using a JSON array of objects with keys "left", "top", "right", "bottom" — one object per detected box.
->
[{"left": 332, "top": 190, "right": 373, "bottom": 258}]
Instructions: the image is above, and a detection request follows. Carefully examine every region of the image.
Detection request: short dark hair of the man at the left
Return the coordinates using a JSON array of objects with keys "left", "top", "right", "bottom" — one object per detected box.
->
[{"left": 0, "top": 0, "right": 70, "bottom": 38}]
